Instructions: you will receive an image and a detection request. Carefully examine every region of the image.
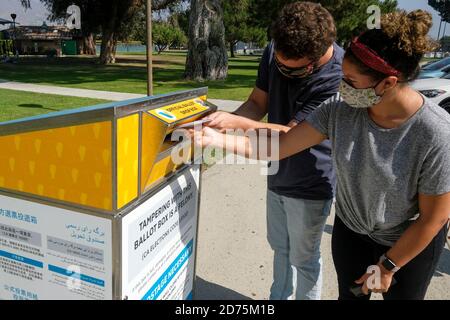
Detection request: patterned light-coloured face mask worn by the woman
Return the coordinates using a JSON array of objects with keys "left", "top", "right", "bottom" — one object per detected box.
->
[{"left": 339, "top": 79, "right": 384, "bottom": 108}]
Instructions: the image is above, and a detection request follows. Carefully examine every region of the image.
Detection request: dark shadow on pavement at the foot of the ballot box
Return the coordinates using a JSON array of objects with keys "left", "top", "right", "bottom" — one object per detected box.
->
[{"left": 194, "top": 277, "right": 252, "bottom": 300}]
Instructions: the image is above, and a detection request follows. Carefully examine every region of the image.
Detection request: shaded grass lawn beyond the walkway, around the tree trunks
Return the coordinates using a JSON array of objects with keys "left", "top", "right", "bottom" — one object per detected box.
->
[{"left": 0, "top": 52, "right": 260, "bottom": 100}]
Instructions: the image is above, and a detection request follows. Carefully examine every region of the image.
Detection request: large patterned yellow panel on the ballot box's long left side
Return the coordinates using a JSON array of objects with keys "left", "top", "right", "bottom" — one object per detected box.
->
[{"left": 0, "top": 121, "right": 112, "bottom": 210}]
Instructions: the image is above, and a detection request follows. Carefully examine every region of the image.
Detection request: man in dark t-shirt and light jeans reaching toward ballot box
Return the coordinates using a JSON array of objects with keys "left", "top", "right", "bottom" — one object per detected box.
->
[{"left": 208, "top": 2, "right": 344, "bottom": 300}]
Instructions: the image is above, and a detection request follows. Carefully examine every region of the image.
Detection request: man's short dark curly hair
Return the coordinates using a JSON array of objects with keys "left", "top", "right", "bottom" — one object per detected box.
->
[{"left": 271, "top": 2, "right": 337, "bottom": 61}]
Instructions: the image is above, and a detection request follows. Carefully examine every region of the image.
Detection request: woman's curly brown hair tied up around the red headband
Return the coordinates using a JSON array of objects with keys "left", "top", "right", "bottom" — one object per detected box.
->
[{"left": 345, "top": 10, "right": 435, "bottom": 81}]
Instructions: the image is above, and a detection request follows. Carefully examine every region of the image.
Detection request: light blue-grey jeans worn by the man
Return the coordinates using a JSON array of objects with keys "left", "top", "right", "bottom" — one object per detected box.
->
[{"left": 267, "top": 190, "right": 333, "bottom": 300}]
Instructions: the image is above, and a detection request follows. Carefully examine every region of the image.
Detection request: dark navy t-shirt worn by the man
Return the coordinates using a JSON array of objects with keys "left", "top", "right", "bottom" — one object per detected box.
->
[{"left": 256, "top": 44, "right": 344, "bottom": 200}]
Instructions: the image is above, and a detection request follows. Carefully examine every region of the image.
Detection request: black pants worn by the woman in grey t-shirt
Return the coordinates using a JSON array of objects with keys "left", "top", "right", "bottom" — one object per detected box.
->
[{"left": 332, "top": 217, "right": 447, "bottom": 300}]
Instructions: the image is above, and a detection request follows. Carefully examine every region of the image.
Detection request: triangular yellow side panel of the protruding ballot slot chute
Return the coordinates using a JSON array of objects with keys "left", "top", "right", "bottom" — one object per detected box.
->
[{"left": 141, "top": 113, "right": 167, "bottom": 190}]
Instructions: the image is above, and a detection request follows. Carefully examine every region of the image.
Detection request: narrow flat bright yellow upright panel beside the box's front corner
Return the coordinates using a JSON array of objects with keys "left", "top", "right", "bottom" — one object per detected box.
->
[{"left": 117, "top": 114, "right": 139, "bottom": 209}]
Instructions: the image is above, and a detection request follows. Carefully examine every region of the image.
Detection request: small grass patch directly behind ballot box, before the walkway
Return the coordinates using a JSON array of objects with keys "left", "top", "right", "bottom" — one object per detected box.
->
[{"left": 0, "top": 89, "right": 107, "bottom": 122}]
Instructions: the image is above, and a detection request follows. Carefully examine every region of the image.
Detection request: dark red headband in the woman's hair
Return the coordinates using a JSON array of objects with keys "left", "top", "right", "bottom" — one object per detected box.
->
[{"left": 350, "top": 38, "right": 401, "bottom": 77}]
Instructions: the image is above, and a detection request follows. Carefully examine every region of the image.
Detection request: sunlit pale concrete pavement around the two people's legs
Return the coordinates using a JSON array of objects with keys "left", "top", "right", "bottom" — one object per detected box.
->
[{"left": 196, "top": 165, "right": 450, "bottom": 300}]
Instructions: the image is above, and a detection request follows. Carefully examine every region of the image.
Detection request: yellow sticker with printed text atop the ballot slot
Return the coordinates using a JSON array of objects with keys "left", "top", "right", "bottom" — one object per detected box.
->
[{"left": 150, "top": 98, "right": 209, "bottom": 124}]
